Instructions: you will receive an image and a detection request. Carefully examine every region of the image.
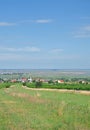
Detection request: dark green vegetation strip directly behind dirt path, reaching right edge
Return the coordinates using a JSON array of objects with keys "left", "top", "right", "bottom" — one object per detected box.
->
[{"left": 23, "top": 82, "right": 90, "bottom": 90}]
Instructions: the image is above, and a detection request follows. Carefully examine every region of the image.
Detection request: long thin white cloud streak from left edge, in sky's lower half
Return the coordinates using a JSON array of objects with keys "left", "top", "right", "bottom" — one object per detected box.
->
[{"left": 0, "top": 47, "right": 40, "bottom": 52}]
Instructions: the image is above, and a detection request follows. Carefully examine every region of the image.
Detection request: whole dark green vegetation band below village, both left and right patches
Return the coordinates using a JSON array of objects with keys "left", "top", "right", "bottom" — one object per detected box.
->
[{"left": 0, "top": 81, "right": 90, "bottom": 91}]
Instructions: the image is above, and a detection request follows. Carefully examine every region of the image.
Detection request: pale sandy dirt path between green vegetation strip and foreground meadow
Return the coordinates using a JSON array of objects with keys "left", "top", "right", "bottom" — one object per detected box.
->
[{"left": 22, "top": 86, "right": 90, "bottom": 95}]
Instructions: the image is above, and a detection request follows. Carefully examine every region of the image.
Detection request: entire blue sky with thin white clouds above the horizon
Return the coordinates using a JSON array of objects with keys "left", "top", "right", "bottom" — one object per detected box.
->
[{"left": 0, "top": 0, "right": 90, "bottom": 69}]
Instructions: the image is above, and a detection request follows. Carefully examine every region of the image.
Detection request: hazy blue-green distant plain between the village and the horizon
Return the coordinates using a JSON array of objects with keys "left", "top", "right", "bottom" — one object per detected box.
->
[{"left": 0, "top": 69, "right": 90, "bottom": 80}]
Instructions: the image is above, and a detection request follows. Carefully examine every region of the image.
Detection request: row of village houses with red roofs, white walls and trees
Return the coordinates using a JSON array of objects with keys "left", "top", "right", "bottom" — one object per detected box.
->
[{"left": 0, "top": 74, "right": 90, "bottom": 84}]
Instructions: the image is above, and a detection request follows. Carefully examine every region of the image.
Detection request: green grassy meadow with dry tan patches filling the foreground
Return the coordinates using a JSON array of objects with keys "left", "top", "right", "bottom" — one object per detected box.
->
[{"left": 0, "top": 85, "right": 90, "bottom": 130}]
